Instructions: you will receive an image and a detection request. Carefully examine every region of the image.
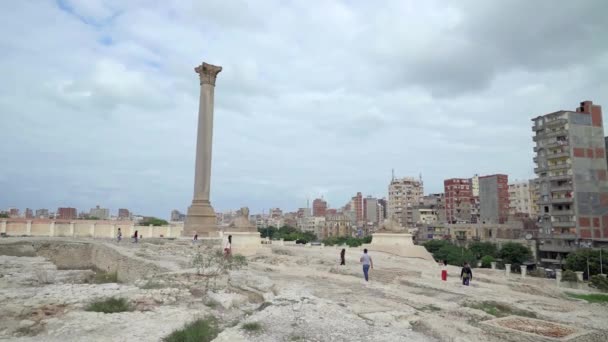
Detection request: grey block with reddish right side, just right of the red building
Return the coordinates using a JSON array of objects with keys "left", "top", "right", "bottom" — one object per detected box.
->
[{"left": 479, "top": 175, "right": 509, "bottom": 223}]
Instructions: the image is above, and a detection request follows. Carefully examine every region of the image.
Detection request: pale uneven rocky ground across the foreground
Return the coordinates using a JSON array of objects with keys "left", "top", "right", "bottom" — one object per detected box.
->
[{"left": 0, "top": 238, "right": 608, "bottom": 342}]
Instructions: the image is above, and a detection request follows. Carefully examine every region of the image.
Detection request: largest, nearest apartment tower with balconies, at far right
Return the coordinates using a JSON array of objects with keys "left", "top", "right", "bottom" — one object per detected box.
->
[{"left": 532, "top": 101, "right": 608, "bottom": 263}]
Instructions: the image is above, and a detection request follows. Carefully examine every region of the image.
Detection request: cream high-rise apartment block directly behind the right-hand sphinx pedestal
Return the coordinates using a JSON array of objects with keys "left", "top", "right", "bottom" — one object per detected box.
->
[{"left": 388, "top": 177, "right": 424, "bottom": 227}]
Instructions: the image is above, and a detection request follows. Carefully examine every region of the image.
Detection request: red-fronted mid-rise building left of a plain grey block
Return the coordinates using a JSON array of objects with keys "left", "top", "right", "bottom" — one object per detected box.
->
[{"left": 443, "top": 178, "right": 474, "bottom": 223}]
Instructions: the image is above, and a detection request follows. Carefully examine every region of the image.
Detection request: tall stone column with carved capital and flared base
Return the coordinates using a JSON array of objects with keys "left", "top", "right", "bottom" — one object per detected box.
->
[{"left": 182, "top": 63, "right": 222, "bottom": 236}]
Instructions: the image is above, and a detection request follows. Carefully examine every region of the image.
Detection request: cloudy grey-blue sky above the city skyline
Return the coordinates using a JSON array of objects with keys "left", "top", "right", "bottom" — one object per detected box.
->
[{"left": 0, "top": 0, "right": 608, "bottom": 217}]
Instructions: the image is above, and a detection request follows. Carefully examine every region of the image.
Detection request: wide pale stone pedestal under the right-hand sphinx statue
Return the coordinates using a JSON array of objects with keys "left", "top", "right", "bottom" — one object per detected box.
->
[{"left": 361, "top": 232, "right": 435, "bottom": 263}]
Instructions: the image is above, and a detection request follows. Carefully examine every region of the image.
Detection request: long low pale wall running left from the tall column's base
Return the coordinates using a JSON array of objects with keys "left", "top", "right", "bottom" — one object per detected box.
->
[{"left": 0, "top": 219, "right": 183, "bottom": 239}]
